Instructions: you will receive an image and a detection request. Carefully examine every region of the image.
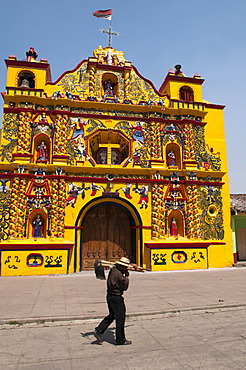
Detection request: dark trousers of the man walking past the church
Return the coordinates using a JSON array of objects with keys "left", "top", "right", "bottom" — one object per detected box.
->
[{"left": 96, "top": 294, "right": 126, "bottom": 342}]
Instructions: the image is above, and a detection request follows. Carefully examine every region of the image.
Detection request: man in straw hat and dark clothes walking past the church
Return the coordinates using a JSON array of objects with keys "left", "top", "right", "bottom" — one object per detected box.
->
[{"left": 94, "top": 257, "right": 132, "bottom": 345}]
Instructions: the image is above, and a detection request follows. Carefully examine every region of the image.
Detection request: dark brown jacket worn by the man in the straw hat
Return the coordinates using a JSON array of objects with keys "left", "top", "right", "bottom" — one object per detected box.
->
[{"left": 107, "top": 266, "right": 129, "bottom": 295}]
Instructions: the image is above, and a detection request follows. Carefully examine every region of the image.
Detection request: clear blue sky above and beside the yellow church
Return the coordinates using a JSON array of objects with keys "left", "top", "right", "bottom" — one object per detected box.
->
[{"left": 0, "top": 0, "right": 246, "bottom": 193}]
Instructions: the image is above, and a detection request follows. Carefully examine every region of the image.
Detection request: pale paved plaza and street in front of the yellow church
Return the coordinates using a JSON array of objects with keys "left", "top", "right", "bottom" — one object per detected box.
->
[{"left": 0, "top": 268, "right": 246, "bottom": 370}]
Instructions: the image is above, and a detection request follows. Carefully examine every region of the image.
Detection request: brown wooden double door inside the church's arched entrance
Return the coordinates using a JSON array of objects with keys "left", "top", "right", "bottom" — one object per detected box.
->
[{"left": 81, "top": 204, "right": 132, "bottom": 270}]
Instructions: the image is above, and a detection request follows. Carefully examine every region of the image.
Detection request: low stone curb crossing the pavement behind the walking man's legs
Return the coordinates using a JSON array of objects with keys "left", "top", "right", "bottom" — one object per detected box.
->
[{"left": 0, "top": 304, "right": 246, "bottom": 330}]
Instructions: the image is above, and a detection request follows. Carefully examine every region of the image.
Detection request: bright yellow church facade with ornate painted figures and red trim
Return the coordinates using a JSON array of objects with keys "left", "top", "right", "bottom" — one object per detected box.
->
[{"left": 0, "top": 46, "right": 233, "bottom": 276}]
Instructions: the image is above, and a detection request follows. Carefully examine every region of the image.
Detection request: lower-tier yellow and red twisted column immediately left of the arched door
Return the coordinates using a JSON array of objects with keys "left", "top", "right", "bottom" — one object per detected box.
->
[{"left": 50, "top": 179, "right": 66, "bottom": 238}]
